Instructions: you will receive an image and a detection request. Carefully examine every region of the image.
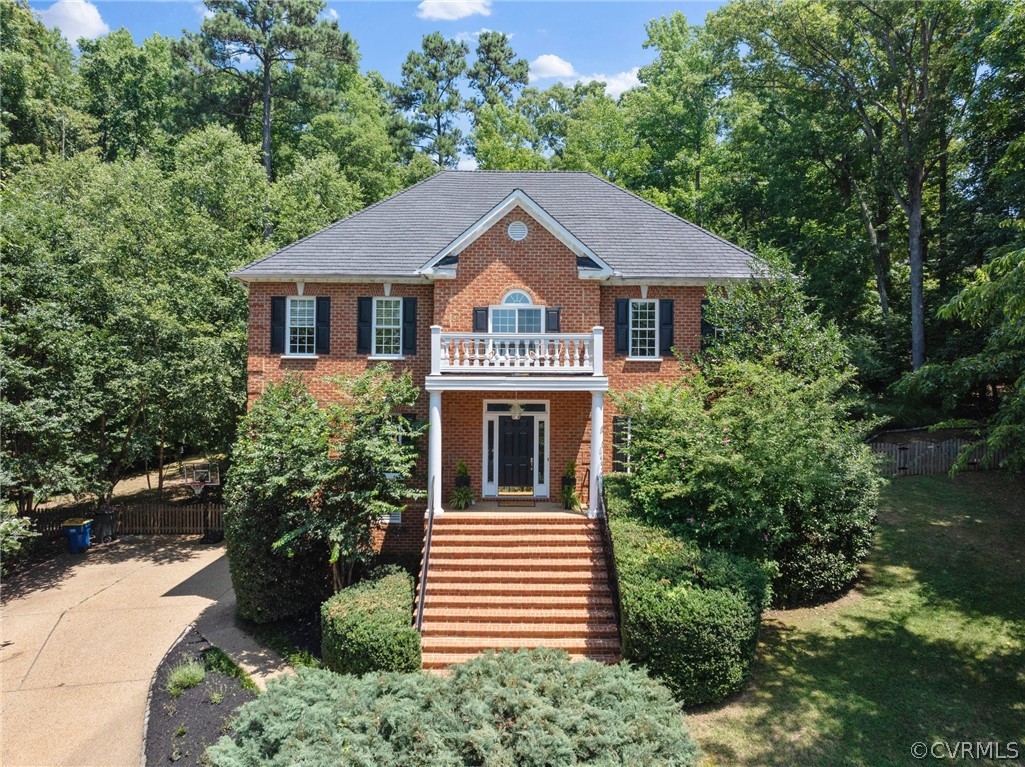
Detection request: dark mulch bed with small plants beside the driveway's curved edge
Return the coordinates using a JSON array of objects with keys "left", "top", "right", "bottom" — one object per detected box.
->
[{"left": 146, "top": 628, "right": 256, "bottom": 767}]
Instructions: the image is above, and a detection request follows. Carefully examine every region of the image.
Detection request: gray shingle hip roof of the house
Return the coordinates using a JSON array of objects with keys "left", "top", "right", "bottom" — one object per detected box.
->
[{"left": 233, "top": 170, "right": 753, "bottom": 280}]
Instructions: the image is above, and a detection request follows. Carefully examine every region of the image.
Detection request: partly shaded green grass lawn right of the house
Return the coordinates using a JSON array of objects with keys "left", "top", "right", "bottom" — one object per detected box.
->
[{"left": 689, "top": 473, "right": 1025, "bottom": 767}]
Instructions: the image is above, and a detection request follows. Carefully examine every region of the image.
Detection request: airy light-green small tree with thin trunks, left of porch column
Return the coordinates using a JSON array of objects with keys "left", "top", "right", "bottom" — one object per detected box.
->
[{"left": 273, "top": 364, "right": 425, "bottom": 592}]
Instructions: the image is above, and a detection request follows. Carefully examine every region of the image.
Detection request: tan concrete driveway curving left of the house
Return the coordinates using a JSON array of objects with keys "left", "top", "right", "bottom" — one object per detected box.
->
[{"left": 0, "top": 535, "right": 234, "bottom": 767}]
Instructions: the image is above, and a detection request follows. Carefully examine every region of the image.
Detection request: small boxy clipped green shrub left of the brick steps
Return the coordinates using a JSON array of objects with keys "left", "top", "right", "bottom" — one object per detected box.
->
[{"left": 321, "top": 565, "right": 420, "bottom": 674}]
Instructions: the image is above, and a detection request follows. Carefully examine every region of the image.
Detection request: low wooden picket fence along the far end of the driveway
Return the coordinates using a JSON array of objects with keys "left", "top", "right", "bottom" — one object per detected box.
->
[{"left": 30, "top": 501, "right": 224, "bottom": 535}]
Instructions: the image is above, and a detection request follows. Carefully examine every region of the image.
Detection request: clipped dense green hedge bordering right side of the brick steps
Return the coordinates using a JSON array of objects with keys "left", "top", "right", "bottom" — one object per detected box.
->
[{"left": 609, "top": 516, "right": 768, "bottom": 705}]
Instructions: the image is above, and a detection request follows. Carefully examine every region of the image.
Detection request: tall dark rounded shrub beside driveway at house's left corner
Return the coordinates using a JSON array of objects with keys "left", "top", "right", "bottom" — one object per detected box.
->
[{"left": 224, "top": 377, "right": 330, "bottom": 623}]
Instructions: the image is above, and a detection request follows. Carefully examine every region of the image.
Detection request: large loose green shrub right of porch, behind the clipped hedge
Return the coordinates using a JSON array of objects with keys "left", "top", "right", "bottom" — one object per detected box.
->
[{"left": 618, "top": 362, "right": 879, "bottom": 605}]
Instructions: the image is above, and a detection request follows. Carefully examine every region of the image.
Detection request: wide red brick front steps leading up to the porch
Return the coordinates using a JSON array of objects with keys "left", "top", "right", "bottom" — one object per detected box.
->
[{"left": 421, "top": 512, "right": 619, "bottom": 670}]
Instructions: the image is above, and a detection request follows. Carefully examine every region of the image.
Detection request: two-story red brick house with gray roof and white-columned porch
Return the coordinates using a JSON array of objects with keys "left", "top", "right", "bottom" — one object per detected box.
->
[{"left": 233, "top": 171, "right": 752, "bottom": 664}]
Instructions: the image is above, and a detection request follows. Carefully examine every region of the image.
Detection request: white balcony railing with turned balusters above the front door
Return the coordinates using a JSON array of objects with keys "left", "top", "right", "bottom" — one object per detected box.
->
[{"left": 431, "top": 325, "right": 603, "bottom": 375}]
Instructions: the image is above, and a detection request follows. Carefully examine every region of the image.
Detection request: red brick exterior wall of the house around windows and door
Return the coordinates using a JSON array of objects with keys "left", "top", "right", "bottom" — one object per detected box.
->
[{"left": 239, "top": 208, "right": 705, "bottom": 559}]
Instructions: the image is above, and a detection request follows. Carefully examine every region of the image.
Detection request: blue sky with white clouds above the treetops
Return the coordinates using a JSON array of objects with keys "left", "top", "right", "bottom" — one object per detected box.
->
[{"left": 32, "top": 0, "right": 723, "bottom": 95}]
